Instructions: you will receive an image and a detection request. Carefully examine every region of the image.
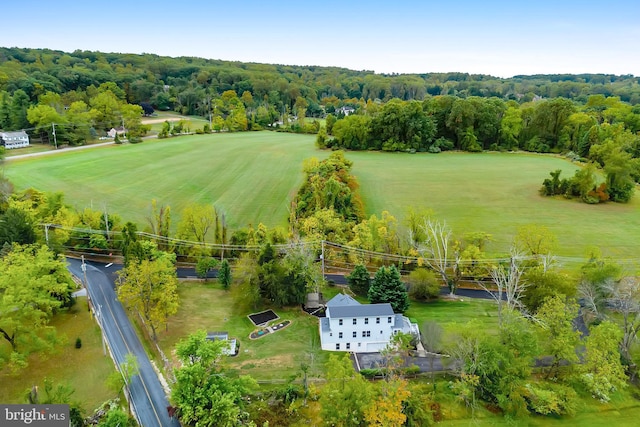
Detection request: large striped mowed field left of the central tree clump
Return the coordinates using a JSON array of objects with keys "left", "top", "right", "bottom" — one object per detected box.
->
[{"left": 6, "top": 132, "right": 322, "bottom": 229}]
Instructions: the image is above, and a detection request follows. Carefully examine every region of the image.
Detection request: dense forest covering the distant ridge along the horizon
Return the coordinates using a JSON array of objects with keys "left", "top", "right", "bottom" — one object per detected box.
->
[{"left": 0, "top": 48, "right": 640, "bottom": 111}]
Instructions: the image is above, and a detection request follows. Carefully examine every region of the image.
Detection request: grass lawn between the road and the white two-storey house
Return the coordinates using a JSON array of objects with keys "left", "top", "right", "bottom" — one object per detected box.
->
[{"left": 158, "top": 282, "right": 328, "bottom": 380}]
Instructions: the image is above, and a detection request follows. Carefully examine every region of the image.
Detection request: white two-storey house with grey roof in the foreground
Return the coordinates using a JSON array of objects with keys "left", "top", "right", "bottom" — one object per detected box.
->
[{"left": 320, "top": 294, "right": 420, "bottom": 353}]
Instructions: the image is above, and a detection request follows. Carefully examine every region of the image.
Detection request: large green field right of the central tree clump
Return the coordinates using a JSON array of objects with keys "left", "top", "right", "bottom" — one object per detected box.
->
[{"left": 348, "top": 152, "right": 640, "bottom": 259}]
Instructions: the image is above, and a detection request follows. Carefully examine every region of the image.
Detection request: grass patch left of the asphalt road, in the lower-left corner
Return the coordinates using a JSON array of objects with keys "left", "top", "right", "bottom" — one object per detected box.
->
[{"left": 0, "top": 298, "right": 115, "bottom": 414}]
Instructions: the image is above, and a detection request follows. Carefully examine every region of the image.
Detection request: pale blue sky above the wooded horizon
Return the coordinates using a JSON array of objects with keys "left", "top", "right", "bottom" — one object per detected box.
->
[{"left": 6, "top": 0, "right": 640, "bottom": 77}]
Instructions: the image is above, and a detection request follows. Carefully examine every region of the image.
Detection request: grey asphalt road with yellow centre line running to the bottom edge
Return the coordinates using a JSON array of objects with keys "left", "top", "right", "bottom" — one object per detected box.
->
[{"left": 67, "top": 258, "right": 180, "bottom": 427}]
